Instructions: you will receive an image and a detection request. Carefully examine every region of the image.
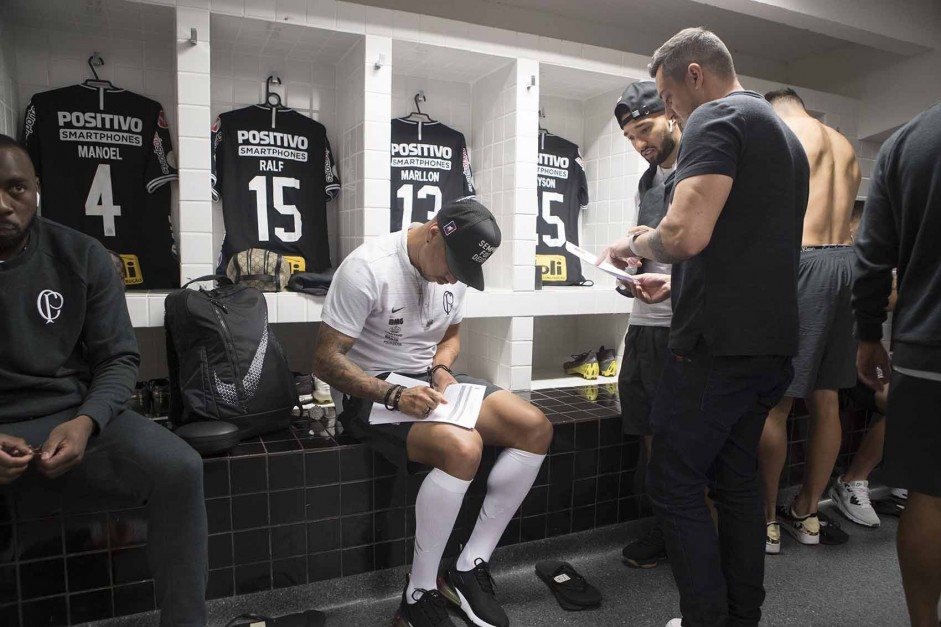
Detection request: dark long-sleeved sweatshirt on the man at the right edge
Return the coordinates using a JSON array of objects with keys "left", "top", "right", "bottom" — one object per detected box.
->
[{"left": 853, "top": 103, "right": 941, "bottom": 372}]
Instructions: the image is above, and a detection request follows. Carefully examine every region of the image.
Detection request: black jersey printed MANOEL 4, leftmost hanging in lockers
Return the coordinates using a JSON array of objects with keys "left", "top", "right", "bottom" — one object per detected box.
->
[{"left": 23, "top": 84, "right": 180, "bottom": 289}]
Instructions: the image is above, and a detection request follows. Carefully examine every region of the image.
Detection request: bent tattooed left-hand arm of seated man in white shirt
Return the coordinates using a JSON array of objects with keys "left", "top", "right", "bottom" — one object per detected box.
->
[{"left": 314, "top": 323, "right": 392, "bottom": 403}]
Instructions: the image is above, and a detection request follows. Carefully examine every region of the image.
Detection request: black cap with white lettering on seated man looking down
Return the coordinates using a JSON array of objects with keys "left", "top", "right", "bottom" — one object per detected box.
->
[{"left": 438, "top": 197, "right": 502, "bottom": 291}]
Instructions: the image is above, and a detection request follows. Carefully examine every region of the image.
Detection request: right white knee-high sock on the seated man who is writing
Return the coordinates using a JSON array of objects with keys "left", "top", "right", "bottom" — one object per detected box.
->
[{"left": 457, "top": 448, "right": 546, "bottom": 571}]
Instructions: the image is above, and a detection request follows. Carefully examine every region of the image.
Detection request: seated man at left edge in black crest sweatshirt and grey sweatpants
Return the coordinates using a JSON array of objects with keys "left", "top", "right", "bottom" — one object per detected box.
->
[{"left": 0, "top": 135, "right": 207, "bottom": 627}]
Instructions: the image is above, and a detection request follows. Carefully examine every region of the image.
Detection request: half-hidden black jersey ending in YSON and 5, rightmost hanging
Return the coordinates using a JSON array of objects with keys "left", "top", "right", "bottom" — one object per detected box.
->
[{"left": 536, "top": 131, "right": 588, "bottom": 285}]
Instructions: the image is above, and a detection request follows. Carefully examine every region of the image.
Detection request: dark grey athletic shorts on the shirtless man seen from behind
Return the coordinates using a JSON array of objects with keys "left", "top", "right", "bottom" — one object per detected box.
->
[{"left": 785, "top": 246, "right": 856, "bottom": 398}]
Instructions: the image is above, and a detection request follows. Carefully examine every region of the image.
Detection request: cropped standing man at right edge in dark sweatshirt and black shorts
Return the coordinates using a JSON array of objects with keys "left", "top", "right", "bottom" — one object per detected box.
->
[{"left": 853, "top": 104, "right": 941, "bottom": 627}]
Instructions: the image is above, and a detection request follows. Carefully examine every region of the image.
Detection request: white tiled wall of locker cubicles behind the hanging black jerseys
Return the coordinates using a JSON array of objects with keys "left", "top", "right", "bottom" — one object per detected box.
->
[{"left": 0, "top": 0, "right": 878, "bottom": 389}]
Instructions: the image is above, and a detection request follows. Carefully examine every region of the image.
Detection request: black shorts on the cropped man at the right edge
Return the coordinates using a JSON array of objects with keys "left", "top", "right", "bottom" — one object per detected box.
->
[{"left": 882, "top": 370, "right": 941, "bottom": 497}]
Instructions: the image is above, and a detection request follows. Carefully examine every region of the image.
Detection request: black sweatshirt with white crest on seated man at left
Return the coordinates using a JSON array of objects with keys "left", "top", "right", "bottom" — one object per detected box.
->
[{"left": 0, "top": 216, "right": 140, "bottom": 433}]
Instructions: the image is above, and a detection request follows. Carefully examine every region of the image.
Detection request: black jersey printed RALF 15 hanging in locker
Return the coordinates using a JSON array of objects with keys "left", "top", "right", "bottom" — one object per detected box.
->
[{"left": 211, "top": 105, "right": 340, "bottom": 272}]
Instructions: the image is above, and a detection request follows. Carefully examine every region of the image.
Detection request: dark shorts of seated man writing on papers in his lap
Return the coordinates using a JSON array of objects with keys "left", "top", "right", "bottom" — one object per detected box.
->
[{"left": 337, "top": 372, "right": 502, "bottom": 472}]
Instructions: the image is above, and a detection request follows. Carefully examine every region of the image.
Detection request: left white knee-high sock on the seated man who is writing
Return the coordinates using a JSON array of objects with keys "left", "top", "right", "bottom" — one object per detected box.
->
[{"left": 405, "top": 468, "right": 471, "bottom": 604}]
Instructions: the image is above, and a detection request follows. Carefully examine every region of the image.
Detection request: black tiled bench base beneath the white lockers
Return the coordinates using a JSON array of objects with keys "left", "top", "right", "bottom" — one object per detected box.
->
[{"left": 0, "top": 387, "right": 868, "bottom": 627}]
